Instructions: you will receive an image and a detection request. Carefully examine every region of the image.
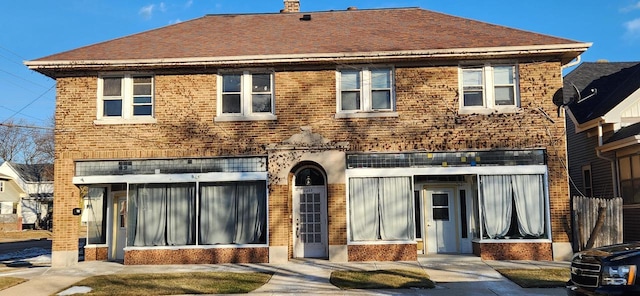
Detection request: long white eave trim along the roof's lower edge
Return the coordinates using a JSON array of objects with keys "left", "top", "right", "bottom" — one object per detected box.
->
[{"left": 25, "top": 43, "right": 592, "bottom": 70}]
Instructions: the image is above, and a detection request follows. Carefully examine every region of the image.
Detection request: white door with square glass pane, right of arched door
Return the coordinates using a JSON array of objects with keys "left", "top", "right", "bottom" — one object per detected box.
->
[{"left": 425, "top": 189, "right": 459, "bottom": 254}]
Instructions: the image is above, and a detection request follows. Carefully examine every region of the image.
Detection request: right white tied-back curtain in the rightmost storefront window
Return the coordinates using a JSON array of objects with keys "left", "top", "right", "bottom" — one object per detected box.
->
[{"left": 511, "top": 175, "right": 545, "bottom": 237}]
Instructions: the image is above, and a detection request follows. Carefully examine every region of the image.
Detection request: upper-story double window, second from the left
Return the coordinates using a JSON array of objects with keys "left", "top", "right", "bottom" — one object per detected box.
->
[{"left": 216, "top": 71, "right": 275, "bottom": 120}]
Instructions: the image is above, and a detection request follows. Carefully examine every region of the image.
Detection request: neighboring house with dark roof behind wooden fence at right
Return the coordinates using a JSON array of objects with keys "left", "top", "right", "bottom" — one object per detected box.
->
[{"left": 564, "top": 62, "right": 640, "bottom": 241}]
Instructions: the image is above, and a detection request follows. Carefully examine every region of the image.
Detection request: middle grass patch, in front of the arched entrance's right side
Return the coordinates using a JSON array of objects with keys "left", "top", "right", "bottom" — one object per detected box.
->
[{"left": 330, "top": 269, "right": 435, "bottom": 290}]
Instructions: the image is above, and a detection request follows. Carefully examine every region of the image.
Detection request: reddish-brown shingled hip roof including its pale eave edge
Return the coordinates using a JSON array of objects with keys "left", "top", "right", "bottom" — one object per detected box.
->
[{"left": 26, "top": 8, "right": 590, "bottom": 74}]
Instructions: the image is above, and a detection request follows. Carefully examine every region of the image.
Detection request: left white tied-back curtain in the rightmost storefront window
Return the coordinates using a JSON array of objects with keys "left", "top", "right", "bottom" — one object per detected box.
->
[{"left": 480, "top": 175, "right": 512, "bottom": 238}]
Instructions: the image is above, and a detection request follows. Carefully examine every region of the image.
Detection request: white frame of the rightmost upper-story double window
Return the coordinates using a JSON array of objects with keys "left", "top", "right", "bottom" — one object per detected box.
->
[{"left": 458, "top": 62, "right": 520, "bottom": 114}]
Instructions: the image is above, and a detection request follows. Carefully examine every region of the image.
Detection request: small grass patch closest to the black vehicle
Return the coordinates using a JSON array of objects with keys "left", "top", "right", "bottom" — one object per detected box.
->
[{"left": 496, "top": 268, "right": 571, "bottom": 288}]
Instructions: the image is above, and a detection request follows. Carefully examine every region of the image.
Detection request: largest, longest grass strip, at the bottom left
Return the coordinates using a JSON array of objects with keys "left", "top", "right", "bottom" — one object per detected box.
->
[{"left": 55, "top": 272, "right": 271, "bottom": 295}]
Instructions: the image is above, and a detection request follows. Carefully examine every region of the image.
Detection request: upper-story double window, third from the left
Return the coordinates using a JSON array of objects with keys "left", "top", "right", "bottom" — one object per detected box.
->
[{"left": 337, "top": 68, "right": 396, "bottom": 118}]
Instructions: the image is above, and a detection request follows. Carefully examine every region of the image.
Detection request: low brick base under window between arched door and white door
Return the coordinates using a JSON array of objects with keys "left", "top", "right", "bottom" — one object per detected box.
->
[{"left": 348, "top": 244, "right": 418, "bottom": 261}]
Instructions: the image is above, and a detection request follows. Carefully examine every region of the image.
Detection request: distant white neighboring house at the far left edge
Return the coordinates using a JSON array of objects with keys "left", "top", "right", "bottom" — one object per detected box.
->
[{"left": 0, "top": 161, "right": 53, "bottom": 228}]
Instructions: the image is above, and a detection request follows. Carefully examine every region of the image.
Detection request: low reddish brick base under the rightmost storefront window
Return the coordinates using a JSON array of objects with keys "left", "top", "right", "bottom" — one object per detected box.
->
[{"left": 473, "top": 242, "right": 553, "bottom": 261}]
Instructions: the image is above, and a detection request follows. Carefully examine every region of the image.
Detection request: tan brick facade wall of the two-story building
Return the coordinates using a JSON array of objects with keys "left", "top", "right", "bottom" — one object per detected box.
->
[{"left": 53, "top": 62, "right": 570, "bottom": 262}]
